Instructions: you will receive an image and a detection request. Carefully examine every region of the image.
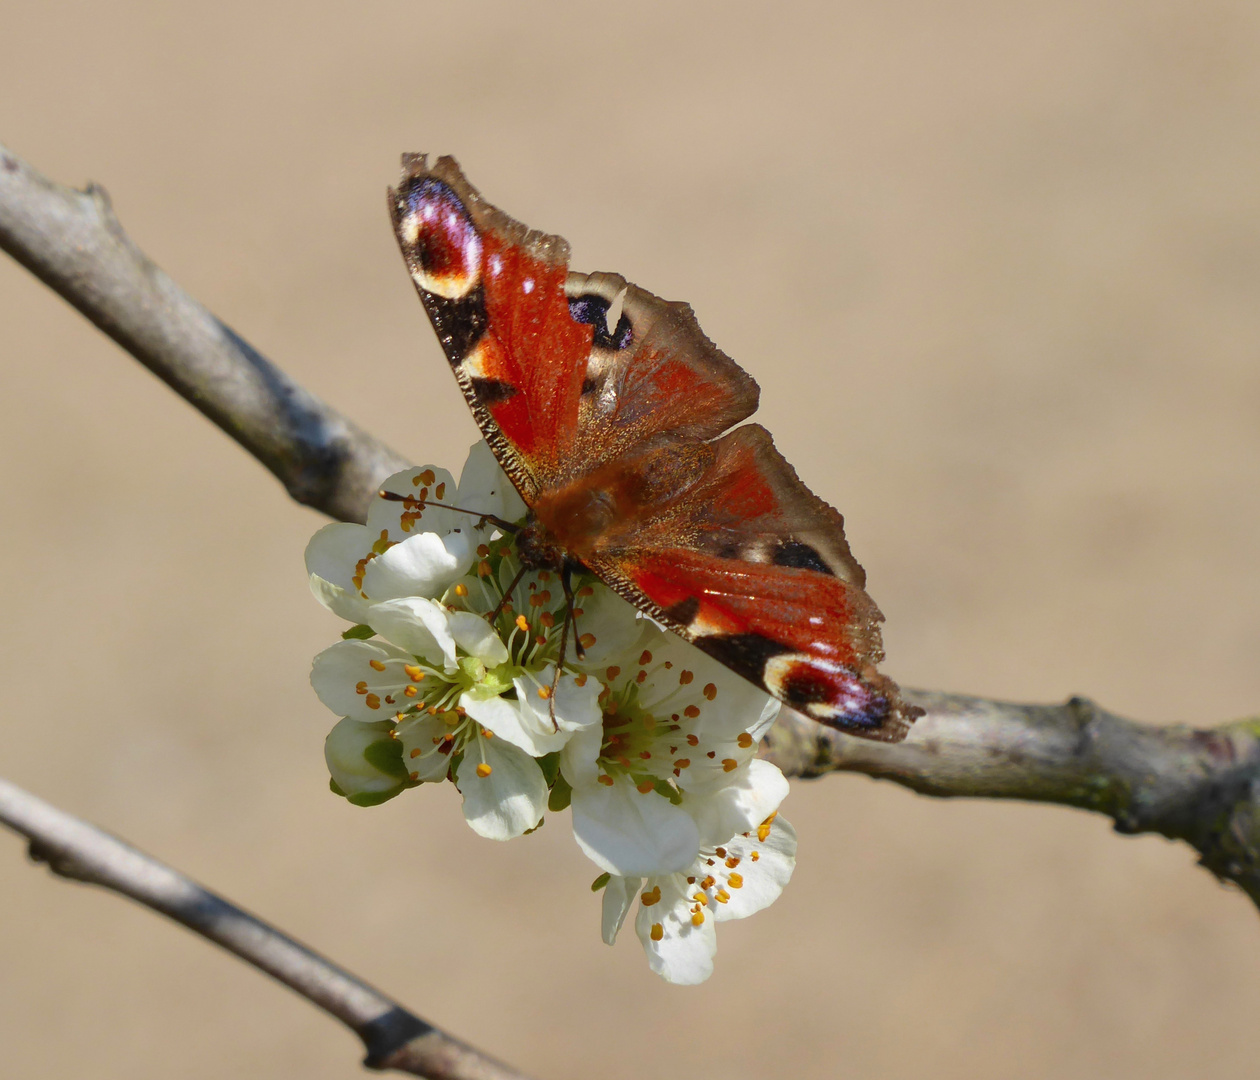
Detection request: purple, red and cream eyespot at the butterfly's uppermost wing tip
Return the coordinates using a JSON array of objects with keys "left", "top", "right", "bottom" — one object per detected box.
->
[{"left": 398, "top": 176, "right": 481, "bottom": 300}]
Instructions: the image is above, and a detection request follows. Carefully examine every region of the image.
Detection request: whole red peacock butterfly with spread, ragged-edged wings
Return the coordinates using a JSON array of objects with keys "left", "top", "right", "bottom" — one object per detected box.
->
[{"left": 389, "top": 155, "right": 919, "bottom": 741}]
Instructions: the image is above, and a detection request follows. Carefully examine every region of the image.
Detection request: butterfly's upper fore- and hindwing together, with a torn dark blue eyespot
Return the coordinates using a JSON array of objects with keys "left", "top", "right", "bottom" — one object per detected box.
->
[{"left": 389, "top": 155, "right": 757, "bottom": 504}]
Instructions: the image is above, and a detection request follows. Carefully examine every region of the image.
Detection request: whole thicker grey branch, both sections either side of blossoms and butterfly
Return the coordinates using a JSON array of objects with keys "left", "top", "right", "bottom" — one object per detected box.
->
[{"left": 7, "top": 139, "right": 1260, "bottom": 905}]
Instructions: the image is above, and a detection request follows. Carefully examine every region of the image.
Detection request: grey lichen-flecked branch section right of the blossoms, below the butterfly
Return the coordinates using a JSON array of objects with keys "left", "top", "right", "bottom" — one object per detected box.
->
[{"left": 761, "top": 691, "right": 1260, "bottom": 906}]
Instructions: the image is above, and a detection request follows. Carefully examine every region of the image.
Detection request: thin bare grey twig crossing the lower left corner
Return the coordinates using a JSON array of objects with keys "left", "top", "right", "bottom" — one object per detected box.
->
[{"left": 0, "top": 780, "right": 536, "bottom": 1080}]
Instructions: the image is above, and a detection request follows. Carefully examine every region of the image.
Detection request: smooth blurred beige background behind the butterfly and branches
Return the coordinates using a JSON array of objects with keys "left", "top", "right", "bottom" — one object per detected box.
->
[{"left": 0, "top": 0, "right": 1260, "bottom": 1080}]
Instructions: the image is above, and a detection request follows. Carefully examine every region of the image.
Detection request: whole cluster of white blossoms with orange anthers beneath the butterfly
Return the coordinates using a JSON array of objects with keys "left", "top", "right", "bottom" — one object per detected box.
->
[{"left": 306, "top": 442, "right": 796, "bottom": 983}]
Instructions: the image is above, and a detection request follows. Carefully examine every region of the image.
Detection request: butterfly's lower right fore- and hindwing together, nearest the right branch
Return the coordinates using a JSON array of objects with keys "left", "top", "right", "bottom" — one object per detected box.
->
[{"left": 592, "top": 425, "right": 917, "bottom": 741}]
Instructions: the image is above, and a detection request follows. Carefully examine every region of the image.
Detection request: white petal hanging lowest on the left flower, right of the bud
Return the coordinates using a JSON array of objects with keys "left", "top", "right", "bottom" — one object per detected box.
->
[{"left": 456, "top": 733, "right": 547, "bottom": 841}]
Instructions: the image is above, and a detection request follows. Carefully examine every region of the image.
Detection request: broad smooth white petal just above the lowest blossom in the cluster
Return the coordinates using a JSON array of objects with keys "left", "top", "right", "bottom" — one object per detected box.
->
[{"left": 572, "top": 780, "right": 700, "bottom": 877}]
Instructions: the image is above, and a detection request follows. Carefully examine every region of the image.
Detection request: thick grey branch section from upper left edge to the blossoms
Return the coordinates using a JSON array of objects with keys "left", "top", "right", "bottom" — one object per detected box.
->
[{"left": 0, "top": 136, "right": 407, "bottom": 520}]
